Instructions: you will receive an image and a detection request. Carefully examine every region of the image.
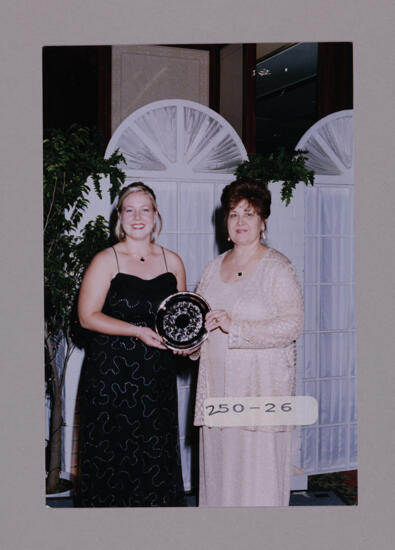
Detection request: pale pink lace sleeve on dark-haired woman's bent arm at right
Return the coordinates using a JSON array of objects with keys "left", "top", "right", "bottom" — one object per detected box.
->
[{"left": 228, "top": 265, "right": 303, "bottom": 349}]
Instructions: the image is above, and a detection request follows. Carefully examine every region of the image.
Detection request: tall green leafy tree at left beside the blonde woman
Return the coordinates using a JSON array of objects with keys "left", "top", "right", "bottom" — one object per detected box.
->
[{"left": 43, "top": 126, "right": 125, "bottom": 493}]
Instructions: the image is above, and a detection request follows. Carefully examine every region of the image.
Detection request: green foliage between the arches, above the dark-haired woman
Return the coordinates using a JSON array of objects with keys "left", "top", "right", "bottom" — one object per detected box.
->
[{"left": 234, "top": 148, "right": 314, "bottom": 206}]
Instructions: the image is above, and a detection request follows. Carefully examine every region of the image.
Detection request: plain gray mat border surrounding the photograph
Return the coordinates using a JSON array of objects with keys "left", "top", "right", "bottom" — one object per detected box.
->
[{"left": 0, "top": 0, "right": 395, "bottom": 550}]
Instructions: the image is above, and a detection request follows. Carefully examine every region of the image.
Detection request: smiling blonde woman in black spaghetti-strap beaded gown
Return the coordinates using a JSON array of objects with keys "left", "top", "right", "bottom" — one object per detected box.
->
[{"left": 75, "top": 182, "right": 185, "bottom": 507}]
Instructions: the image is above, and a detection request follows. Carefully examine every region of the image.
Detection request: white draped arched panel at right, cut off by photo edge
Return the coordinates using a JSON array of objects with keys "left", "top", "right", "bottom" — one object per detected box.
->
[{"left": 297, "top": 111, "right": 357, "bottom": 474}]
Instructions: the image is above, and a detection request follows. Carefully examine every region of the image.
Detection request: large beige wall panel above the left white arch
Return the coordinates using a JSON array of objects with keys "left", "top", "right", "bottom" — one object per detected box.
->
[{"left": 111, "top": 46, "right": 209, "bottom": 132}]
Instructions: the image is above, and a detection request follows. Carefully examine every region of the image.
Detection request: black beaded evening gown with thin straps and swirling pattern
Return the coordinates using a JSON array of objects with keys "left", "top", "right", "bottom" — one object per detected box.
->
[{"left": 75, "top": 250, "right": 184, "bottom": 507}]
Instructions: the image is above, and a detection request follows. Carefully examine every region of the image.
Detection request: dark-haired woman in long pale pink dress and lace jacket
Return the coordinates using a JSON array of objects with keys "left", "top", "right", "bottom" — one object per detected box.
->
[{"left": 192, "top": 181, "right": 303, "bottom": 506}]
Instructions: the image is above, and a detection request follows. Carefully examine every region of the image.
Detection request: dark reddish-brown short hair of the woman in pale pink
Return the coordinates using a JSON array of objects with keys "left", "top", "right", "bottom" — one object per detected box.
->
[{"left": 221, "top": 180, "right": 272, "bottom": 225}]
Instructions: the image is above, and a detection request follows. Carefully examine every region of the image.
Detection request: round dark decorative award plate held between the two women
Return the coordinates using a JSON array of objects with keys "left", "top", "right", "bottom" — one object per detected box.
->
[{"left": 156, "top": 292, "right": 210, "bottom": 350}]
